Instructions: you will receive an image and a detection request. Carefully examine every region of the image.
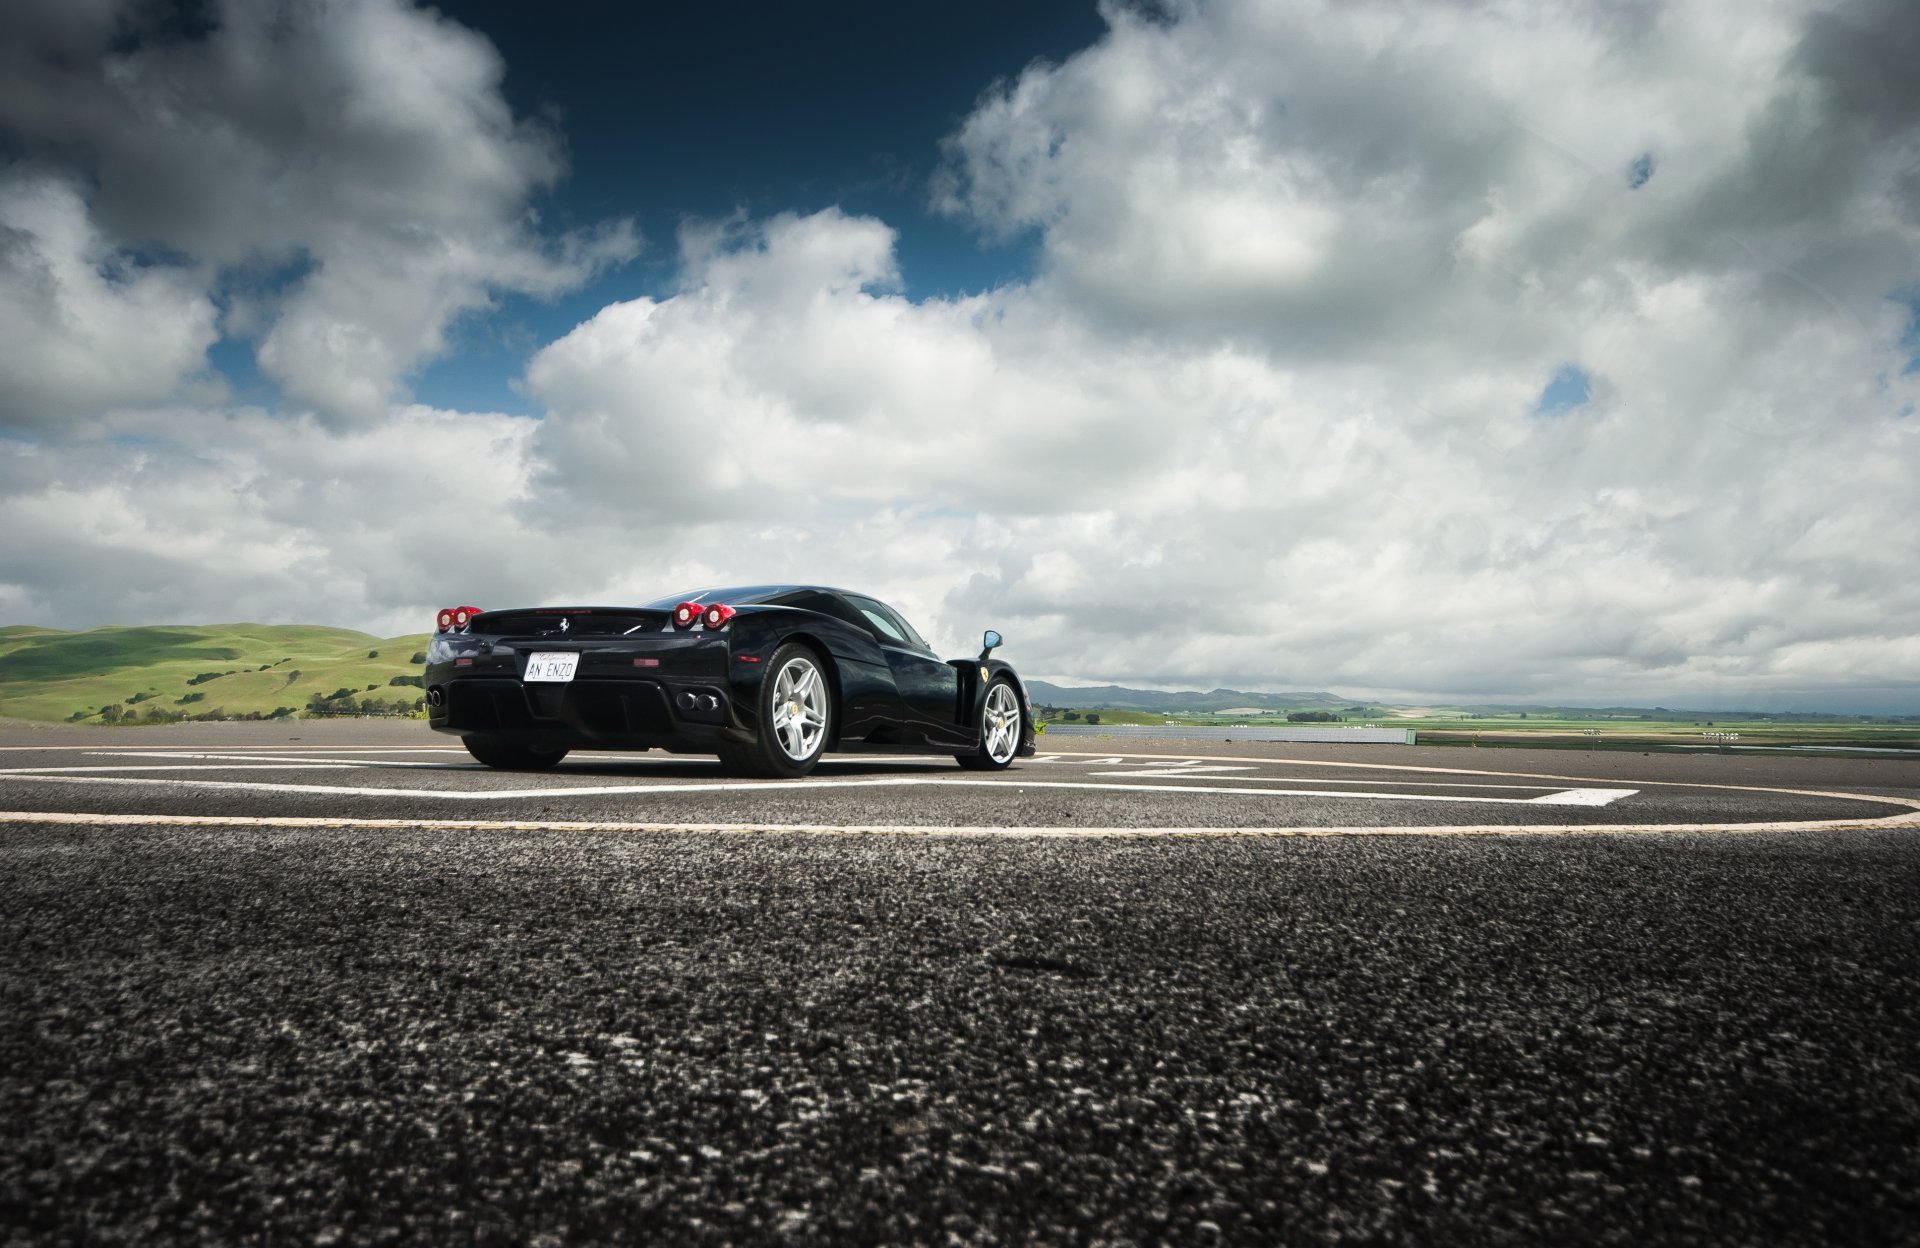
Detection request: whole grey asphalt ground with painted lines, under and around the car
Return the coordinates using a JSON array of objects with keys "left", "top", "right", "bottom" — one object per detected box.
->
[{"left": 0, "top": 722, "right": 1920, "bottom": 1244}]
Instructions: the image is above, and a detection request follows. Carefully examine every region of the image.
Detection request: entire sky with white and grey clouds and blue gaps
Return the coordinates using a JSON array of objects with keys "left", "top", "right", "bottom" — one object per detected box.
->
[{"left": 0, "top": 0, "right": 1920, "bottom": 712}]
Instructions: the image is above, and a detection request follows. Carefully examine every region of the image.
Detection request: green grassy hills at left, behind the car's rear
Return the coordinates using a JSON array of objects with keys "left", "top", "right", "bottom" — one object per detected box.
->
[{"left": 0, "top": 624, "right": 428, "bottom": 724}]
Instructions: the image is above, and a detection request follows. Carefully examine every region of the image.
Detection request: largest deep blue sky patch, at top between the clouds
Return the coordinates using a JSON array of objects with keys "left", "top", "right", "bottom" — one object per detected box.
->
[{"left": 384, "top": 0, "right": 1106, "bottom": 417}]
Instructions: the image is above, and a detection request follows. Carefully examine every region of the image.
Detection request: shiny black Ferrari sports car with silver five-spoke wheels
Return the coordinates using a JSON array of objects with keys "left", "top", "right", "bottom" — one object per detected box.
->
[{"left": 426, "top": 586, "right": 1035, "bottom": 776}]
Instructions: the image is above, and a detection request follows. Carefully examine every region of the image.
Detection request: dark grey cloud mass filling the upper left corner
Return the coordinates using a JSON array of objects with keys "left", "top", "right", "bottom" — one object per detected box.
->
[{"left": 0, "top": 0, "right": 637, "bottom": 422}]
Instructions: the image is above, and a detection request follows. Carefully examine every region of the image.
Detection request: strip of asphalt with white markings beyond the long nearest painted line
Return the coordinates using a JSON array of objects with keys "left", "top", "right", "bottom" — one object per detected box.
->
[{"left": 0, "top": 720, "right": 1920, "bottom": 835}]
